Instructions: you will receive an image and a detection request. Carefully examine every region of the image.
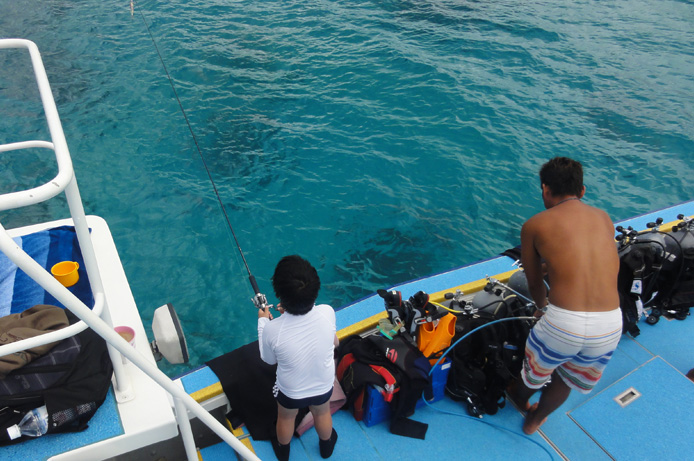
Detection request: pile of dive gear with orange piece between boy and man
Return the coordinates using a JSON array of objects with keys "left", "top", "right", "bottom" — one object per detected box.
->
[{"left": 346, "top": 271, "right": 533, "bottom": 424}]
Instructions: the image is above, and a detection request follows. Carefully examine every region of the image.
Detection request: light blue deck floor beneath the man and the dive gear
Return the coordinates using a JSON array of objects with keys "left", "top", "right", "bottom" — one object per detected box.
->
[{"left": 202, "top": 310, "right": 694, "bottom": 461}]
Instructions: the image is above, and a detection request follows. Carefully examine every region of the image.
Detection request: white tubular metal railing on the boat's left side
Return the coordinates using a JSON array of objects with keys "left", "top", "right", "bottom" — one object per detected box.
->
[{"left": 0, "top": 39, "right": 259, "bottom": 461}]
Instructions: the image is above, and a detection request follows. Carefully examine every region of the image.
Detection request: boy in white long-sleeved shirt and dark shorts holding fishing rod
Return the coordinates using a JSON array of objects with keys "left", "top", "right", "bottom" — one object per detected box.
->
[{"left": 258, "top": 255, "right": 337, "bottom": 461}]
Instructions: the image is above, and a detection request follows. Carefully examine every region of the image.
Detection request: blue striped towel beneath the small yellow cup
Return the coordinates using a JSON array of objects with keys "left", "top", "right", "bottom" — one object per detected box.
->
[{"left": 0, "top": 226, "right": 94, "bottom": 317}]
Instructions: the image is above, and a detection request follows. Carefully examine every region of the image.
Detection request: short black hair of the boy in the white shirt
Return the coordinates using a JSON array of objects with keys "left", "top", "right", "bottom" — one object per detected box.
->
[{"left": 272, "top": 255, "right": 320, "bottom": 315}]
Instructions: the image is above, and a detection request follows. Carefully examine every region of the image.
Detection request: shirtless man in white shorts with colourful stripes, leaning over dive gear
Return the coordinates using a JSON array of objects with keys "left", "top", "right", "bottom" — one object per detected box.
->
[{"left": 509, "top": 157, "right": 622, "bottom": 434}]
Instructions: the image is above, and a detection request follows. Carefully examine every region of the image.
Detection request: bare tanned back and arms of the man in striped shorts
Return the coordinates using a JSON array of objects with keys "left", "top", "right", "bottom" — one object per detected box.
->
[{"left": 521, "top": 191, "right": 619, "bottom": 311}]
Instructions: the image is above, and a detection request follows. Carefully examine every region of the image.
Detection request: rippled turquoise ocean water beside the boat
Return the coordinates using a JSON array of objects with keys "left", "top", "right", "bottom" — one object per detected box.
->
[{"left": 0, "top": 0, "right": 694, "bottom": 375}]
